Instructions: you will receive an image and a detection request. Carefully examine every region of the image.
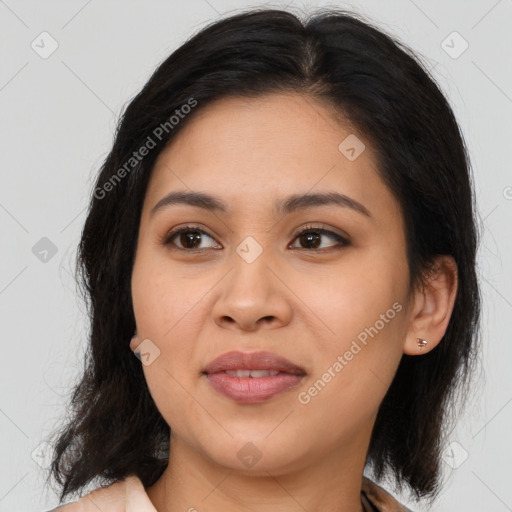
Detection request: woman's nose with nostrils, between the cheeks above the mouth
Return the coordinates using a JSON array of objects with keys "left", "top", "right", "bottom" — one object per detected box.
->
[{"left": 213, "top": 251, "right": 293, "bottom": 331}]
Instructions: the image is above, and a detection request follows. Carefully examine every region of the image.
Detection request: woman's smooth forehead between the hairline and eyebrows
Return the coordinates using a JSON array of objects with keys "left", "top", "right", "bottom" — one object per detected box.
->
[{"left": 146, "top": 94, "right": 397, "bottom": 222}]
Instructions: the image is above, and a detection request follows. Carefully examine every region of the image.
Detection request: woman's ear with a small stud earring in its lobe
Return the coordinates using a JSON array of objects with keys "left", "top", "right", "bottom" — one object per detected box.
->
[{"left": 403, "top": 255, "right": 458, "bottom": 356}]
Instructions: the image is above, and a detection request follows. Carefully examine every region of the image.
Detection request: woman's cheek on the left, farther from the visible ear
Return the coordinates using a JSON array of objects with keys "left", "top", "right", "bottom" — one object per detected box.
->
[{"left": 132, "top": 251, "right": 213, "bottom": 406}]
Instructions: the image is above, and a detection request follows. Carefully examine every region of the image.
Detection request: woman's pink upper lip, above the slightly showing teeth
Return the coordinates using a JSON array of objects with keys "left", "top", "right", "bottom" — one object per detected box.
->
[{"left": 204, "top": 350, "right": 306, "bottom": 375}]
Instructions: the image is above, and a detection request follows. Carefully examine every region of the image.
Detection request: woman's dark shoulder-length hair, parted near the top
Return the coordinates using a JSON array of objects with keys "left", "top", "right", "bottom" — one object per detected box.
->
[{"left": 46, "top": 5, "right": 480, "bottom": 503}]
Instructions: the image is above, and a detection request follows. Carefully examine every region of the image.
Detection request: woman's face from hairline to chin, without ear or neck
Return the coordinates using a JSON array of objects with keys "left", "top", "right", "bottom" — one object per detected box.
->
[{"left": 130, "top": 94, "right": 416, "bottom": 474}]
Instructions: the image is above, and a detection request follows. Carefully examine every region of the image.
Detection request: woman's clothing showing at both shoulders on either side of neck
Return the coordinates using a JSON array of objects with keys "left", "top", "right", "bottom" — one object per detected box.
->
[{"left": 48, "top": 475, "right": 412, "bottom": 512}]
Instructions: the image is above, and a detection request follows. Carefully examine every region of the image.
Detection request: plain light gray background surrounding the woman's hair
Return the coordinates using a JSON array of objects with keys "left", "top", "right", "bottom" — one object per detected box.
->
[{"left": 0, "top": 0, "right": 512, "bottom": 512}]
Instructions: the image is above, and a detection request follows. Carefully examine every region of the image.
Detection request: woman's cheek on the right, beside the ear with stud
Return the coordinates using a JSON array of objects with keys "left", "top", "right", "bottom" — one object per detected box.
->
[{"left": 296, "top": 253, "right": 408, "bottom": 402}]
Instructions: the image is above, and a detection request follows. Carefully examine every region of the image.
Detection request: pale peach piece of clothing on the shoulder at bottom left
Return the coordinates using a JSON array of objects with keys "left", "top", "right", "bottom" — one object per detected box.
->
[{"left": 48, "top": 475, "right": 156, "bottom": 512}]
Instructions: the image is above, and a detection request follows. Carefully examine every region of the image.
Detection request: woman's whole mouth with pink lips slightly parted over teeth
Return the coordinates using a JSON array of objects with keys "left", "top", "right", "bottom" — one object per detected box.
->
[{"left": 203, "top": 351, "right": 306, "bottom": 404}]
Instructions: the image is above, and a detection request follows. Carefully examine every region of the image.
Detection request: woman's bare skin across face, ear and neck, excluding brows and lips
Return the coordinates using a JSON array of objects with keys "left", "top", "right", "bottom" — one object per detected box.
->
[{"left": 130, "top": 93, "right": 457, "bottom": 512}]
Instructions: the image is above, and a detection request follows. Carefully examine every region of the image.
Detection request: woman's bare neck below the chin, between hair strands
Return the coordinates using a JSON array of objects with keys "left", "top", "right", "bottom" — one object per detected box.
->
[{"left": 147, "top": 430, "right": 368, "bottom": 512}]
